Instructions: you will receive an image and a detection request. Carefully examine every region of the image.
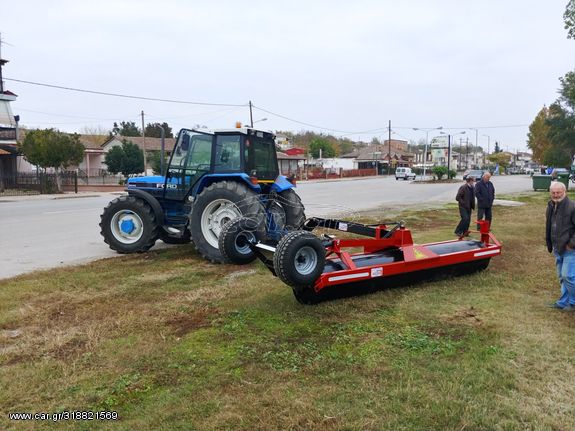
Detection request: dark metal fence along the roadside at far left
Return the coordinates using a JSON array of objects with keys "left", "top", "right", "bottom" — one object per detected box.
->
[{"left": 0, "top": 172, "right": 78, "bottom": 196}]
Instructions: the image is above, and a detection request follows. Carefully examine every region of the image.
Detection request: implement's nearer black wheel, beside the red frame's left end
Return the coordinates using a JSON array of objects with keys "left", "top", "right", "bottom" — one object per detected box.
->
[{"left": 274, "top": 230, "right": 325, "bottom": 297}]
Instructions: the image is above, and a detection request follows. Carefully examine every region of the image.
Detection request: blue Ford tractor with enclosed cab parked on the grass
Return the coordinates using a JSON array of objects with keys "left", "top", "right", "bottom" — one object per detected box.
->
[{"left": 100, "top": 128, "right": 305, "bottom": 263}]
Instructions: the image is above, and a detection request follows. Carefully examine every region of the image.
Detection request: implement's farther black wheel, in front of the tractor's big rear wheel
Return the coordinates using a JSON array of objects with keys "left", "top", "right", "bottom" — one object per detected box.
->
[{"left": 218, "top": 217, "right": 261, "bottom": 265}]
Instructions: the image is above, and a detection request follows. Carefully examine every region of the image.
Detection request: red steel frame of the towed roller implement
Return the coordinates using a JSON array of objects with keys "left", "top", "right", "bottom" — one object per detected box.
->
[{"left": 314, "top": 221, "right": 501, "bottom": 292}]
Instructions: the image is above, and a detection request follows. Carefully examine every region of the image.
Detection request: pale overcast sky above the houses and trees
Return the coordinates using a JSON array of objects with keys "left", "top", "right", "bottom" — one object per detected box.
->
[{"left": 0, "top": 0, "right": 575, "bottom": 151}]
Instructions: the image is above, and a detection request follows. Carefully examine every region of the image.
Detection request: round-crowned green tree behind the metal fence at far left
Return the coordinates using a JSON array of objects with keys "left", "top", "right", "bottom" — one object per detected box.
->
[{"left": 19, "top": 129, "right": 85, "bottom": 191}]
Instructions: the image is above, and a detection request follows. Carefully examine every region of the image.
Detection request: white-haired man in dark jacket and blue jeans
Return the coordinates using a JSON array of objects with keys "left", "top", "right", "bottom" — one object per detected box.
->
[{"left": 545, "top": 181, "right": 575, "bottom": 310}]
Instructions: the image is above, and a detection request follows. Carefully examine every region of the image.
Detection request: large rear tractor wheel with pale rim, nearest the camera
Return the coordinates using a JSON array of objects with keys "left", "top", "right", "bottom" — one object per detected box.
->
[{"left": 190, "top": 181, "right": 265, "bottom": 263}]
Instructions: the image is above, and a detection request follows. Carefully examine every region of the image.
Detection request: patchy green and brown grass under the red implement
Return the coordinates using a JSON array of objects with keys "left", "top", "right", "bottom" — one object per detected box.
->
[{"left": 0, "top": 193, "right": 575, "bottom": 430}]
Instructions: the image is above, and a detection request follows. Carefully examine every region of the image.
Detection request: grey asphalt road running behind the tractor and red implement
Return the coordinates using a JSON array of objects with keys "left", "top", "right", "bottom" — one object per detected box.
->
[{"left": 0, "top": 176, "right": 532, "bottom": 279}]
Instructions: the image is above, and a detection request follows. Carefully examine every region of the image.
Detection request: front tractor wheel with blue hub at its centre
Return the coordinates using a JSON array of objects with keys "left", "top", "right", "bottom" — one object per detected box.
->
[{"left": 100, "top": 196, "right": 159, "bottom": 254}]
